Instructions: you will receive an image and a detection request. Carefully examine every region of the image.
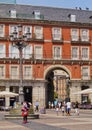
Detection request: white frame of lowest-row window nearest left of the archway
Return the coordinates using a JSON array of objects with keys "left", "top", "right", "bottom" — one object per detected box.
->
[{"left": 23, "top": 65, "right": 32, "bottom": 80}]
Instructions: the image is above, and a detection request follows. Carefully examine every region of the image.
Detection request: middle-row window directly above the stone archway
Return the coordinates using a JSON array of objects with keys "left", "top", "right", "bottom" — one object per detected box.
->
[{"left": 53, "top": 46, "right": 61, "bottom": 59}]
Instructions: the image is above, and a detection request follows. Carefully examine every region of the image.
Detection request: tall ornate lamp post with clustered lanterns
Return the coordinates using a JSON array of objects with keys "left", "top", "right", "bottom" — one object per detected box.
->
[{"left": 10, "top": 25, "right": 31, "bottom": 104}]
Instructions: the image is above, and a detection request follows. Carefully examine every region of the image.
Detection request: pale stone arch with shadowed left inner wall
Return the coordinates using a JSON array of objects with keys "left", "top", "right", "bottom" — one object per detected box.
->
[{"left": 44, "top": 65, "right": 71, "bottom": 106}]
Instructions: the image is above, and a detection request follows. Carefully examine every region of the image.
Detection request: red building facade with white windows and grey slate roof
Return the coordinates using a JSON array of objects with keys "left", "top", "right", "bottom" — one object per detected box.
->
[{"left": 0, "top": 4, "right": 92, "bottom": 106}]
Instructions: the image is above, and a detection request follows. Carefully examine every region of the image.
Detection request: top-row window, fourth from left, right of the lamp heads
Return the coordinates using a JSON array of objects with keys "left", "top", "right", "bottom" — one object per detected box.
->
[{"left": 34, "top": 26, "right": 43, "bottom": 39}]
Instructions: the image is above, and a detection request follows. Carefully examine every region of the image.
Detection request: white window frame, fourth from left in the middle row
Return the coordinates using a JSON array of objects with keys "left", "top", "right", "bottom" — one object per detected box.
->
[{"left": 34, "top": 45, "right": 43, "bottom": 59}]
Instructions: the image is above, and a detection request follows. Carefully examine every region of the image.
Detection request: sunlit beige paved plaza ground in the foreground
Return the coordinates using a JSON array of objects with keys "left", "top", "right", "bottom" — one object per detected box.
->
[{"left": 0, "top": 109, "right": 92, "bottom": 130}]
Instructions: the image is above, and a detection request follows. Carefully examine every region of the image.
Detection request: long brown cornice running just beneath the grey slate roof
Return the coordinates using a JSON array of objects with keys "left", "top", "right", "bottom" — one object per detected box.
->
[{"left": 0, "top": 18, "right": 92, "bottom": 28}]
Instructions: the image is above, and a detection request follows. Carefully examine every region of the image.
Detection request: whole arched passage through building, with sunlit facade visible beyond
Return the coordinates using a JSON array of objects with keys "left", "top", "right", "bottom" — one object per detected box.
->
[{"left": 44, "top": 65, "right": 71, "bottom": 106}]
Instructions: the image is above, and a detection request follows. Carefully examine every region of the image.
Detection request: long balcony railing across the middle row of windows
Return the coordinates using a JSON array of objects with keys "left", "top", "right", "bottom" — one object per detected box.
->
[{"left": 0, "top": 53, "right": 92, "bottom": 61}]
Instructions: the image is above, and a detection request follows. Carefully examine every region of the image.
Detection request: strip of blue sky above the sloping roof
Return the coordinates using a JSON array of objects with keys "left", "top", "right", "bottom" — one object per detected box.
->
[{"left": 16, "top": 0, "right": 92, "bottom": 10}]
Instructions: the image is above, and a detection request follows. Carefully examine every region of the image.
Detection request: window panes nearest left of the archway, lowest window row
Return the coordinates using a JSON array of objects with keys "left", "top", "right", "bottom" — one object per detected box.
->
[{"left": 24, "top": 66, "right": 32, "bottom": 79}]
